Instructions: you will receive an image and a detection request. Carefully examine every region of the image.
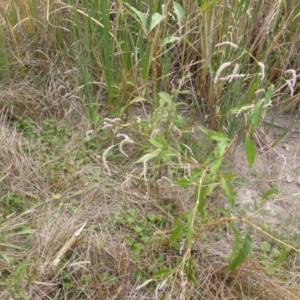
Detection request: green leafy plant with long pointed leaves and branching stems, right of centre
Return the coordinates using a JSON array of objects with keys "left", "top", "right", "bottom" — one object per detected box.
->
[{"left": 137, "top": 90, "right": 295, "bottom": 290}]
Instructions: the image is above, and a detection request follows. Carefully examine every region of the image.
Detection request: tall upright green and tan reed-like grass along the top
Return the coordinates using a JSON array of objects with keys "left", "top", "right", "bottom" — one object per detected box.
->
[{"left": 0, "top": 0, "right": 300, "bottom": 126}]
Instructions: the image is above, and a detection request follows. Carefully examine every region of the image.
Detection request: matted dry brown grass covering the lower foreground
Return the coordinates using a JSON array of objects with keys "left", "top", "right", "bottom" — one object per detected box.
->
[{"left": 0, "top": 116, "right": 300, "bottom": 300}]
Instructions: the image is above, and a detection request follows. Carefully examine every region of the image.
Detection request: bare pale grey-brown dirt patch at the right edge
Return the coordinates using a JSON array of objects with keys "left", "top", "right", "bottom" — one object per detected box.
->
[{"left": 233, "top": 115, "right": 300, "bottom": 235}]
